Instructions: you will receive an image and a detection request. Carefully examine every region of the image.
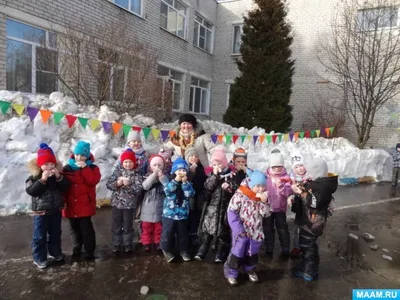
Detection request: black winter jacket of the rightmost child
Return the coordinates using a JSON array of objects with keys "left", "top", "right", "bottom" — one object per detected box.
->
[{"left": 292, "top": 176, "right": 338, "bottom": 236}]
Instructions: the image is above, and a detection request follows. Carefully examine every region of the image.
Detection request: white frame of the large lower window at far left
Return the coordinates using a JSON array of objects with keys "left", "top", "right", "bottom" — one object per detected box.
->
[{"left": 5, "top": 17, "right": 60, "bottom": 95}]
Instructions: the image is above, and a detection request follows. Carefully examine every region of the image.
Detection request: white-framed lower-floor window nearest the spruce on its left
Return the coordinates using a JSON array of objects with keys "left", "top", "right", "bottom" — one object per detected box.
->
[{"left": 189, "top": 77, "right": 210, "bottom": 114}]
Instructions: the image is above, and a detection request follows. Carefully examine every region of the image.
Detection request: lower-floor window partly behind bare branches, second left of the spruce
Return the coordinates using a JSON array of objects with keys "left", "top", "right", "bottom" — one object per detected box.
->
[{"left": 158, "top": 66, "right": 183, "bottom": 111}]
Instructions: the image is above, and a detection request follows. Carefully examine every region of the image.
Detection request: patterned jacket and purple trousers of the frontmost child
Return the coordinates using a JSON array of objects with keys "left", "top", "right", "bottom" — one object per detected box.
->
[{"left": 224, "top": 182, "right": 270, "bottom": 278}]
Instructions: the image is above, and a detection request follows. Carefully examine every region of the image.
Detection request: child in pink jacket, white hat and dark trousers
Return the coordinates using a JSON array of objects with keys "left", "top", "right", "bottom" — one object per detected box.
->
[{"left": 263, "top": 149, "right": 293, "bottom": 256}]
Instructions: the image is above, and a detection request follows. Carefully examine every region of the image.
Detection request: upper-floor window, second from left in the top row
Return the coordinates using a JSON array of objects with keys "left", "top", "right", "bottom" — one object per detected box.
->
[{"left": 160, "top": 0, "right": 186, "bottom": 38}]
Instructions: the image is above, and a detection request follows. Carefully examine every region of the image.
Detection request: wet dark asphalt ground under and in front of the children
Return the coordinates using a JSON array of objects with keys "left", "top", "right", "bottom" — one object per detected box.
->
[{"left": 0, "top": 184, "right": 400, "bottom": 300}]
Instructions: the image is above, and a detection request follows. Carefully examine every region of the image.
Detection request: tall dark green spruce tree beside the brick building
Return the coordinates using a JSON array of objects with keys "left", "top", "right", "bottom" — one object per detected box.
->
[{"left": 224, "top": 0, "right": 294, "bottom": 132}]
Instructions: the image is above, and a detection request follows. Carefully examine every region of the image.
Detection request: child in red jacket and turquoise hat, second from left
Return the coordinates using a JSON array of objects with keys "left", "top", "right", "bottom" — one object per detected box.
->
[{"left": 63, "top": 141, "right": 101, "bottom": 259}]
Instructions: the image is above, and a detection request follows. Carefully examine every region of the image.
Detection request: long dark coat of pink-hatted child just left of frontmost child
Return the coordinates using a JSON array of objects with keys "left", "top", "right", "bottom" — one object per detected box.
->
[{"left": 199, "top": 168, "right": 233, "bottom": 236}]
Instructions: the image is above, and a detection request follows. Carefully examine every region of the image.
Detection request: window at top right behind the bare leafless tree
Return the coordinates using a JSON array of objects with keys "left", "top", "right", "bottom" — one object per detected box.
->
[{"left": 357, "top": 7, "right": 398, "bottom": 30}]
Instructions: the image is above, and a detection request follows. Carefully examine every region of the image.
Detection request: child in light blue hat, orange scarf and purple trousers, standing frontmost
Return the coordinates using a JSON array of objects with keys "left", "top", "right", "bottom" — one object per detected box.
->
[{"left": 224, "top": 171, "right": 270, "bottom": 285}]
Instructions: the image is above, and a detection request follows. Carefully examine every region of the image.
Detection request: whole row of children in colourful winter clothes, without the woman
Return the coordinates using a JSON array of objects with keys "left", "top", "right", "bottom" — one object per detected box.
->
[{"left": 26, "top": 132, "right": 337, "bottom": 285}]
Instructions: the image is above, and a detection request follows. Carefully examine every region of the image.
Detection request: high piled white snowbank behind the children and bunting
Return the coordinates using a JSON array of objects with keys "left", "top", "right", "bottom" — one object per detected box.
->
[{"left": 0, "top": 91, "right": 392, "bottom": 215}]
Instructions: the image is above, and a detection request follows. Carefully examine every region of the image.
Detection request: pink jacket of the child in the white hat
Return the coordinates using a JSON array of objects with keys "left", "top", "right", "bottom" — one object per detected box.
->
[{"left": 265, "top": 168, "right": 293, "bottom": 212}]
